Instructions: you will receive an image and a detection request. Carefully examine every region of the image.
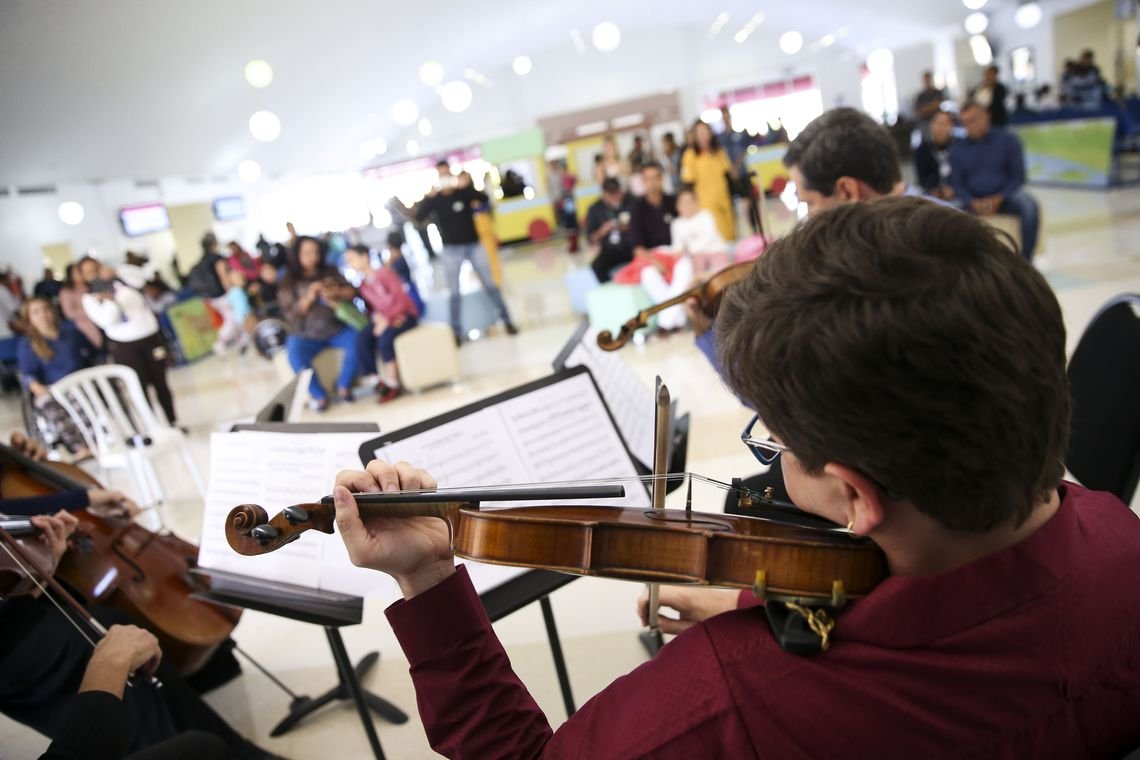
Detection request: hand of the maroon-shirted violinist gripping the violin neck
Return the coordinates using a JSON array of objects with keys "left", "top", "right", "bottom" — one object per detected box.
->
[{"left": 333, "top": 459, "right": 455, "bottom": 599}]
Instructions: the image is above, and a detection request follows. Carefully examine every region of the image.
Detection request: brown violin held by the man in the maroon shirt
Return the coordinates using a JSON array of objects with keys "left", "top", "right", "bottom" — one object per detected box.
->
[{"left": 226, "top": 485, "right": 887, "bottom": 607}]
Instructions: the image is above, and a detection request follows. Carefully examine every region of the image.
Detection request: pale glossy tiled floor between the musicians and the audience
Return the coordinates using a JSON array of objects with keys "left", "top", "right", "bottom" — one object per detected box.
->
[{"left": 0, "top": 185, "right": 1140, "bottom": 760}]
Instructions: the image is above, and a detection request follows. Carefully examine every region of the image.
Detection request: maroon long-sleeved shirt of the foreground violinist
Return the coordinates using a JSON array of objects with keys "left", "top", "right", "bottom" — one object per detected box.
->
[{"left": 388, "top": 484, "right": 1140, "bottom": 760}]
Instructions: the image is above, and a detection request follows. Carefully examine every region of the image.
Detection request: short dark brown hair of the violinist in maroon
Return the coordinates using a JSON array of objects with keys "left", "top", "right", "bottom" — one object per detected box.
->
[{"left": 717, "top": 198, "right": 1069, "bottom": 532}]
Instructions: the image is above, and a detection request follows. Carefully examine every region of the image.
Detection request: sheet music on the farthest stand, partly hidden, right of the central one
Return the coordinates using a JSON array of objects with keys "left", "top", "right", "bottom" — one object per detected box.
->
[{"left": 565, "top": 327, "right": 654, "bottom": 469}]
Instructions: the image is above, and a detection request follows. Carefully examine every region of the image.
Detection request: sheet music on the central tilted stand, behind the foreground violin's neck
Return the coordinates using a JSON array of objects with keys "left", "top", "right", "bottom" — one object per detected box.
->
[{"left": 374, "top": 374, "right": 650, "bottom": 593}]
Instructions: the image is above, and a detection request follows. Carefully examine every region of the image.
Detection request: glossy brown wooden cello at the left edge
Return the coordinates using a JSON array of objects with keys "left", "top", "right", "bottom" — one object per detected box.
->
[{"left": 0, "top": 444, "right": 241, "bottom": 675}]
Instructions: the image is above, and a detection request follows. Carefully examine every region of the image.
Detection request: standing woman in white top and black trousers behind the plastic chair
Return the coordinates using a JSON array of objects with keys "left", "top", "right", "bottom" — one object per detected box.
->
[{"left": 79, "top": 258, "right": 178, "bottom": 425}]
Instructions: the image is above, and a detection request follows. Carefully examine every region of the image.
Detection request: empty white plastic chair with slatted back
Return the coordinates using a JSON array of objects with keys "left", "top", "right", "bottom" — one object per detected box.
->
[{"left": 51, "top": 365, "right": 205, "bottom": 506}]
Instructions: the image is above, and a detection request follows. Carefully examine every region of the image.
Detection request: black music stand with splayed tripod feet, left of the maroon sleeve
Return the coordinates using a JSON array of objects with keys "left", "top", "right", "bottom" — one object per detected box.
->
[{"left": 192, "top": 570, "right": 408, "bottom": 760}]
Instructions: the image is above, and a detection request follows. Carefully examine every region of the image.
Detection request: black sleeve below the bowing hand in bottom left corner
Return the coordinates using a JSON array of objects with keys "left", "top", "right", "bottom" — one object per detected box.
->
[{"left": 40, "top": 690, "right": 135, "bottom": 760}]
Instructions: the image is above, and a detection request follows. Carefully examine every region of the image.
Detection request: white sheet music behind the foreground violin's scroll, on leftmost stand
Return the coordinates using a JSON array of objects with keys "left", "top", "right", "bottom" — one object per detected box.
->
[{"left": 198, "top": 432, "right": 399, "bottom": 600}]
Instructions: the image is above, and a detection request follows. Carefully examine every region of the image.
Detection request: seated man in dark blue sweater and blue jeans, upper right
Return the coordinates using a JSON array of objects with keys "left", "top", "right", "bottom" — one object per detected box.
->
[{"left": 950, "top": 103, "right": 1041, "bottom": 261}]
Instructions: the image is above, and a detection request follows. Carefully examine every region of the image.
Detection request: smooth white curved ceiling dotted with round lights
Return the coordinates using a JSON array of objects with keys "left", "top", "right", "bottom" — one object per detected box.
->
[{"left": 0, "top": 0, "right": 1012, "bottom": 185}]
